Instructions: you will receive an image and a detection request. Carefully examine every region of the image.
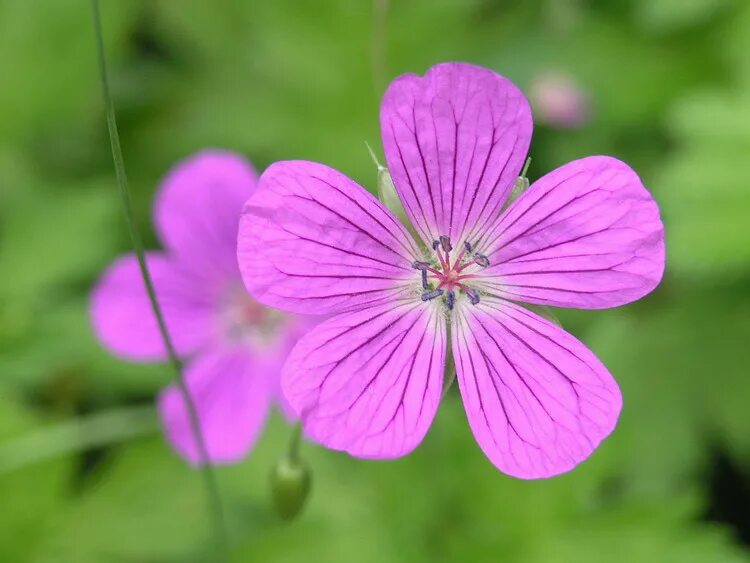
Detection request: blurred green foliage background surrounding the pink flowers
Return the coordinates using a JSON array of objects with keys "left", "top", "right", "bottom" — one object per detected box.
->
[{"left": 0, "top": 0, "right": 750, "bottom": 563}]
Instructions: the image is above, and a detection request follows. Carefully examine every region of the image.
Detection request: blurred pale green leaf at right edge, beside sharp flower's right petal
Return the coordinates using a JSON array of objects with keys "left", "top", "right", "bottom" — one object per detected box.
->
[{"left": 655, "top": 89, "right": 750, "bottom": 276}]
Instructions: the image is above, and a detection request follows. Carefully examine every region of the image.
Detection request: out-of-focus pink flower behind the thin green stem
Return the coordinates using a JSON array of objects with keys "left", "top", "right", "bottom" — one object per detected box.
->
[{"left": 91, "top": 151, "right": 304, "bottom": 464}]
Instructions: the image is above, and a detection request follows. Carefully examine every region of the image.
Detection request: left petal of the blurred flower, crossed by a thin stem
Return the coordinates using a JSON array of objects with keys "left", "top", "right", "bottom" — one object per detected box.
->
[{"left": 91, "top": 252, "right": 214, "bottom": 361}]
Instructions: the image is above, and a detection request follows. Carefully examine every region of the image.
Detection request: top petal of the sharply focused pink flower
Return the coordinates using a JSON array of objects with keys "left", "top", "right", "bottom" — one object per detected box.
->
[{"left": 380, "top": 63, "right": 532, "bottom": 245}]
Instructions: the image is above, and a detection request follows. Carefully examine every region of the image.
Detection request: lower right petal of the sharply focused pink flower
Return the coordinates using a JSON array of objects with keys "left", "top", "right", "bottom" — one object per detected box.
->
[{"left": 453, "top": 298, "right": 622, "bottom": 479}]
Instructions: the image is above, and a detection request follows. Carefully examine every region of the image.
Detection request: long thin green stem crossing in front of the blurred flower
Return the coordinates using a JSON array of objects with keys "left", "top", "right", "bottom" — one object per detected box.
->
[{"left": 91, "top": 0, "right": 228, "bottom": 559}]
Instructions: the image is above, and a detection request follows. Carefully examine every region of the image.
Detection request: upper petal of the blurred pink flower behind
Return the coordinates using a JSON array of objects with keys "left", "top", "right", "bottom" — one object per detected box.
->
[{"left": 154, "top": 150, "right": 256, "bottom": 277}]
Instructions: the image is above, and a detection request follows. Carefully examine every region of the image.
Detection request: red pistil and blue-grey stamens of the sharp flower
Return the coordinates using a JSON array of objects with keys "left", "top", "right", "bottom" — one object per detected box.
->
[{"left": 412, "top": 235, "right": 490, "bottom": 309}]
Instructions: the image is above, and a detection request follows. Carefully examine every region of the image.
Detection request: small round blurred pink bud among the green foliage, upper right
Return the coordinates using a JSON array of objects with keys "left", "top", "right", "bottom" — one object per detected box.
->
[{"left": 530, "top": 71, "right": 591, "bottom": 129}]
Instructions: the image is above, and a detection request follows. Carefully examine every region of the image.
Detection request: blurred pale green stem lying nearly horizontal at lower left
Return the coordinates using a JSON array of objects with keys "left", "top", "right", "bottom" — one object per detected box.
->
[{"left": 0, "top": 405, "right": 159, "bottom": 474}]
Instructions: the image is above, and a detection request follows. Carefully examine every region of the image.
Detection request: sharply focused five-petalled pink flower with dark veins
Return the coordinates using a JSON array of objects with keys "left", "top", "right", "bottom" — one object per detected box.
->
[{"left": 239, "top": 63, "right": 664, "bottom": 479}]
